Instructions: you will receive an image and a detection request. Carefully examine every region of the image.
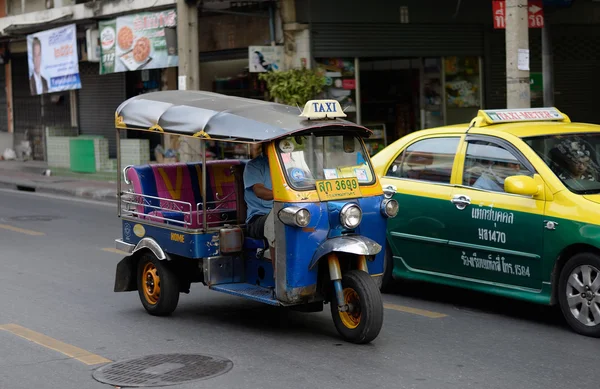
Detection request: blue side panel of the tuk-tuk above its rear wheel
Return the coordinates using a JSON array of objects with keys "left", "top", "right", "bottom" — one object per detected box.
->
[{"left": 123, "top": 219, "right": 219, "bottom": 258}]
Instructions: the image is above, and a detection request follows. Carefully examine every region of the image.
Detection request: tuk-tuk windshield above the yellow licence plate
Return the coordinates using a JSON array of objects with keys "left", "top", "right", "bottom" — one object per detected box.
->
[{"left": 276, "top": 134, "right": 375, "bottom": 190}]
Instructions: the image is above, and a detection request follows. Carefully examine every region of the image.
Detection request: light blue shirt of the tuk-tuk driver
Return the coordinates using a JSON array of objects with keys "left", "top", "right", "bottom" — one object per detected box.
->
[{"left": 244, "top": 155, "right": 273, "bottom": 223}]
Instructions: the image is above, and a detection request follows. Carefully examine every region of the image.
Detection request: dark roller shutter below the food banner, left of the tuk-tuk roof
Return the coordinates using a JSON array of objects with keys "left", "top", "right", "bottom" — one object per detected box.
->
[{"left": 79, "top": 62, "right": 126, "bottom": 158}]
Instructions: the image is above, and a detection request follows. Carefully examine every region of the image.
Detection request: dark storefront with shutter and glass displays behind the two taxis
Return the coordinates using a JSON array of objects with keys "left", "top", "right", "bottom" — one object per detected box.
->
[{"left": 311, "top": 23, "right": 484, "bottom": 153}]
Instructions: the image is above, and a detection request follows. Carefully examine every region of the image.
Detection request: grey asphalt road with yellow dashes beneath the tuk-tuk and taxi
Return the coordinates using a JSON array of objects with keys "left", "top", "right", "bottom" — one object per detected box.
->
[{"left": 0, "top": 186, "right": 600, "bottom": 389}]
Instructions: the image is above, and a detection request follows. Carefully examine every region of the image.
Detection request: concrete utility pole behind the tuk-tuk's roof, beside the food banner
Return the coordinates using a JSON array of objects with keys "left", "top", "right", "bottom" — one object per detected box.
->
[{"left": 176, "top": 0, "right": 200, "bottom": 162}]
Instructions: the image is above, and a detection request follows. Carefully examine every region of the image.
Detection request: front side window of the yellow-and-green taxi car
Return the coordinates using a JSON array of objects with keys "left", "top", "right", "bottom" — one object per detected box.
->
[{"left": 463, "top": 140, "right": 533, "bottom": 192}]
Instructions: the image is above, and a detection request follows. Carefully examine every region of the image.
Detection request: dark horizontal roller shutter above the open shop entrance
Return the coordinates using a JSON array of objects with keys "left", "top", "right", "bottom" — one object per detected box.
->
[{"left": 311, "top": 23, "right": 483, "bottom": 57}]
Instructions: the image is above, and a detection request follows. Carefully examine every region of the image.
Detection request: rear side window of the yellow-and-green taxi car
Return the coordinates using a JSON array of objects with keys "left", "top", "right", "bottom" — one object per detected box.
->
[{"left": 386, "top": 137, "right": 460, "bottom": 184}]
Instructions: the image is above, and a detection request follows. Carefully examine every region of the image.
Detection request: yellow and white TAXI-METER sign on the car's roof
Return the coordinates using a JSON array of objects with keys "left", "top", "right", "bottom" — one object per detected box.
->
[{"left": 473, "top": 107, "right": 571, "bottom": 127}]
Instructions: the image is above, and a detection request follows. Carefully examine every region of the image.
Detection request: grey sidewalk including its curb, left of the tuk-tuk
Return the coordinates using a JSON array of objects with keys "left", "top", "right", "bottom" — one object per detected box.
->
[{"left": 0, "top": 161, "right": 117, "bottom": 203}]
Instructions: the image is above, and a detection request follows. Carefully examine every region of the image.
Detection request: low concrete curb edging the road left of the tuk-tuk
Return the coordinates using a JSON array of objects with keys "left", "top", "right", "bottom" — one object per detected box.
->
[{"left": 0, "top": 176, "right": 117, "bottom": 204}]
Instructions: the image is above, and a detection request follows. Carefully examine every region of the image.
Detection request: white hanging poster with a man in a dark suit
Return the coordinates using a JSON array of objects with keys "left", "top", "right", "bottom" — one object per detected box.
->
[{"left": 27, "top": 24, "right": 81, "bottom": 96}]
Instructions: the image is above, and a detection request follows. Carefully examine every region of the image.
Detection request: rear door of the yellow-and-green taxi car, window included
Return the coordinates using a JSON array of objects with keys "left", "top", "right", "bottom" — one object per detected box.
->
[{"left": 381, "top": 134, "right": 461, "bottom": 273}]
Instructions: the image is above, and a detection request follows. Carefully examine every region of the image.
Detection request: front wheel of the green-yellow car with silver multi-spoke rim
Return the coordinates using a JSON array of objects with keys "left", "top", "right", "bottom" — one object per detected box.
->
[{"left": 558, "top": 253, "right": 600, "bottom": 338}]
